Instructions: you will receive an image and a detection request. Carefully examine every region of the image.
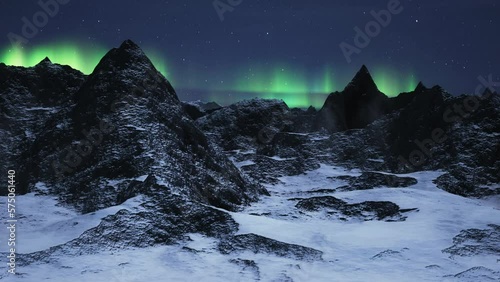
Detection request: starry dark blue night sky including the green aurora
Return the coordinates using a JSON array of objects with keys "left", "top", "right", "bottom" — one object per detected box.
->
[{"left": 0, "top": 0, "right": 500, "bottom": 107}]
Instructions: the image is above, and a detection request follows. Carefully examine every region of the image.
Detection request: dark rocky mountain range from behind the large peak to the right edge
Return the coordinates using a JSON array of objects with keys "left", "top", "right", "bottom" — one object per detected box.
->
[{"left": 197, "top": 66, "right": 500, "bottom": 197}]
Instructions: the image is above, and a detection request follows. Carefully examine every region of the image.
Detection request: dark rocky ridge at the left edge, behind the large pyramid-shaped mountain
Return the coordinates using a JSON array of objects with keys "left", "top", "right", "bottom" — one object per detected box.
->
[{"left": 0, "top": 58, "right": 85, "bottom": 194}]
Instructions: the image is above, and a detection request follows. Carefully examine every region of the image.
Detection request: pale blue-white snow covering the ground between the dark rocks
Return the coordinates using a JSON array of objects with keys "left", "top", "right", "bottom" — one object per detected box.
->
[{"left": 0, "top": 163, "right": 500, "bottom": 282}]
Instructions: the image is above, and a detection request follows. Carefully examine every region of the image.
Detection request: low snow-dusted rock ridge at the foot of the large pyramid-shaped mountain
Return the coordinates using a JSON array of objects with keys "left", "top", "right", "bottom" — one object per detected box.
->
[{"left": 12, "top": 191, "right": 238, "bottom": 266}]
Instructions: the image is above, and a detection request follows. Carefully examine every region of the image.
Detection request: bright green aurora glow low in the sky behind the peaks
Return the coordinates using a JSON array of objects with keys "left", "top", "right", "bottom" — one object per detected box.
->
[{"left": 0, "top": 41, "right": 417, "bottom": 107}]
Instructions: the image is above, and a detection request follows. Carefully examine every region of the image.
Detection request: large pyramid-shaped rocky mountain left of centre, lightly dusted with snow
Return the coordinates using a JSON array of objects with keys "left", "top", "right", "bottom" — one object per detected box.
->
[{"left": 6, "top": 41, "right": 263, "bottom": 212}]
